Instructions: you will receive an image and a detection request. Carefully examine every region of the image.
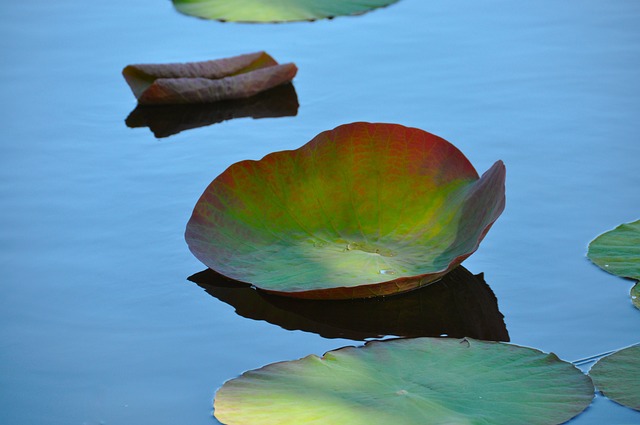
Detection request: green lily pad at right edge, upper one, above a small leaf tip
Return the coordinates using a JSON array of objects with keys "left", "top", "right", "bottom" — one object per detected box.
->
[{"left": 587, "top": 220, "right": 640, "bottom": 280}]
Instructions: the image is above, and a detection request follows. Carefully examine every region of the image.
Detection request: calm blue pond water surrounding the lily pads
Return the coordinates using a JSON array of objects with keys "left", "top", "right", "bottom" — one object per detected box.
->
[{"left": 0, "top": 0, "right": 640, "bottom": 425}]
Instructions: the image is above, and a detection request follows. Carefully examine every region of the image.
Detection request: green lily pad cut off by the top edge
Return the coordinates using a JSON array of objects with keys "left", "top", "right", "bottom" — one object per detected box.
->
[{"left": 173, "top": 0, "right": 398, "bottom": 22}]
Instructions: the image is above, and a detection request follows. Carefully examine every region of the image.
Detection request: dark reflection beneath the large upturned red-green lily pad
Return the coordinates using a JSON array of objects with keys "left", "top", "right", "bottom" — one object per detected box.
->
[{"left": 189, "top": 266, "right": 509, "bottom": 341}]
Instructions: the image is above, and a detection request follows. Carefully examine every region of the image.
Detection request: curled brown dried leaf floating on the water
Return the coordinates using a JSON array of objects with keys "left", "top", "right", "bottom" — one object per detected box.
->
[{"left": 122, "top": 52, "right": 298, "bottom": 104}]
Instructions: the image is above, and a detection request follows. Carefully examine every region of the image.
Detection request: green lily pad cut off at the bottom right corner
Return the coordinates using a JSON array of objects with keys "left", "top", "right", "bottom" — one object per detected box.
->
[{"left": 589, "top": 345, "right": 640, "bottom": 410}]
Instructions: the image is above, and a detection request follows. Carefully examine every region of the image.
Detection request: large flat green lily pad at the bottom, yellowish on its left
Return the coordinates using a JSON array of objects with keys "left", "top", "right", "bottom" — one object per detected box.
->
[{"left": 214, "top": 338, "right": 594, "bottom": 425}]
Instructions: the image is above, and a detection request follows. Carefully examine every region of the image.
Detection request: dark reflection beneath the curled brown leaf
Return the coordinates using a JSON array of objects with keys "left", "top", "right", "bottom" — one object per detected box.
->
[{"left": 125, "top": 84, "right": 299, "bottom": 139}]
